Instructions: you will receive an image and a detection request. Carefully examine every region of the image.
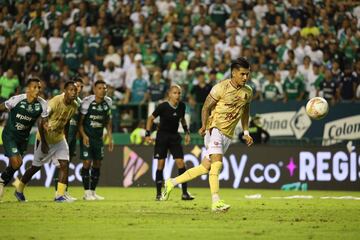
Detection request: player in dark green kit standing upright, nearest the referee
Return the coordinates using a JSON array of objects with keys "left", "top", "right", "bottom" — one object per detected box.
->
[{"left": 79, "top": 80, "right": 114, "bottom": 200}]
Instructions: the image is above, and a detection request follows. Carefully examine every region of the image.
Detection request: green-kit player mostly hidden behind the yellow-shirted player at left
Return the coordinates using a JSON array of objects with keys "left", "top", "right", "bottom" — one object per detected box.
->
[{"left": 54, "top": 77, "right": 84, "bottom": 201}]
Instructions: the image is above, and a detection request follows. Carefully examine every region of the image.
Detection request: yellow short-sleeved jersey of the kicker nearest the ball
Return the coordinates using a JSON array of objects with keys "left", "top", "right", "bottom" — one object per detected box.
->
[{"left": 206, "top": 79, "right": 252, "bottom": 138}]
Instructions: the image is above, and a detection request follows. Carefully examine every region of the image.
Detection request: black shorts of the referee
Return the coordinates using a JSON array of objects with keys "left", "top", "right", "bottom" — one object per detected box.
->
[{"left": 154, "top": 132, "right": 184, "bottom": 159}]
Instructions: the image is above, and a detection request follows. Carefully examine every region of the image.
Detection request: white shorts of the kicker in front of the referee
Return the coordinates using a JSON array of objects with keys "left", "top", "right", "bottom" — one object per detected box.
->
[{"left": 204, "top": 128, "right": 231, "bottom": 158}]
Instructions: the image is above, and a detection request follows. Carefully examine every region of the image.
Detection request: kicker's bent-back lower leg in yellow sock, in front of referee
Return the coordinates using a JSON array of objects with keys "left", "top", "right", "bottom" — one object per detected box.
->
[{"left": 161, "top": 163, "right": 209, "bottom": 201}]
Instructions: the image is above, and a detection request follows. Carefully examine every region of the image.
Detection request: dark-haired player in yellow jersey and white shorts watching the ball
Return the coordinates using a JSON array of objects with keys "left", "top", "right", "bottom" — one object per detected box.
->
[{"left": 162, "top": 58, "right": 253, "bottom": 212}]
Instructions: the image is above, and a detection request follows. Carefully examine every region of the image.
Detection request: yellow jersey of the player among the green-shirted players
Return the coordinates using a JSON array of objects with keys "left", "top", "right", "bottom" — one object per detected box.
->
[{"left": 36, "top": 94, "right": 78, "bottom": 144}]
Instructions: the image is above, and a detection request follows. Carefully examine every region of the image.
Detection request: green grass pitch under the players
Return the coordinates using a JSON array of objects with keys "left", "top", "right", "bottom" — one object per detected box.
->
[{"left": 0, "top": 187, "right": 360, "bottom": 240}]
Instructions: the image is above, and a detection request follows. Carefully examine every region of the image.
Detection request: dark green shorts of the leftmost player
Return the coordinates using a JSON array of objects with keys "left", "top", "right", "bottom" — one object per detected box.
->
[{"left": 2, "top": 131, "right": 28, "bottom": 158}]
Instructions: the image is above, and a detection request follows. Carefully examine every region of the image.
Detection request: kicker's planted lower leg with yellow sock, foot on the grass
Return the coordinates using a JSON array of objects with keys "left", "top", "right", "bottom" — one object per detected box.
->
[{"left": 209, "top": 161, "right": 230, "bottom": 212}]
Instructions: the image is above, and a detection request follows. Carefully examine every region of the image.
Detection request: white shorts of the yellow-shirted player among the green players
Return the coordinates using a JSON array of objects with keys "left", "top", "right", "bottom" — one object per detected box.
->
[{"left": 32, "top": 139, "right": 70, "bottom": 167}]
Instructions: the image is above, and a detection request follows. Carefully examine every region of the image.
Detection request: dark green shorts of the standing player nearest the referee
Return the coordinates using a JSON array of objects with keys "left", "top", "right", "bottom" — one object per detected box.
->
[{"left": 80, "top": 139, "right": 104, "bottom": 160}]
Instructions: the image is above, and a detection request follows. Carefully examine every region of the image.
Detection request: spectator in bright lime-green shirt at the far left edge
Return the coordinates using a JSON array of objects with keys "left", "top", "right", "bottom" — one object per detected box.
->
[{"left": 0, "top": 68, "right": 20, "bottom": 102}]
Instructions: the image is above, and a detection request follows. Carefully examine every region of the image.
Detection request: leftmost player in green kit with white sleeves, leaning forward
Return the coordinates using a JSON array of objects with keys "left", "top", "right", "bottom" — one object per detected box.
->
[{"left": 0, "top": 78, "right": 47, "bottom": 200}]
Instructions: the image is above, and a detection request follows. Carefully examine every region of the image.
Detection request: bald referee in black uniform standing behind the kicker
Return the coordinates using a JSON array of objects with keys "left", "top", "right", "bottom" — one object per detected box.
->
[{"left": 145, "top": 85, "right": 194, "bottom": 200}]
